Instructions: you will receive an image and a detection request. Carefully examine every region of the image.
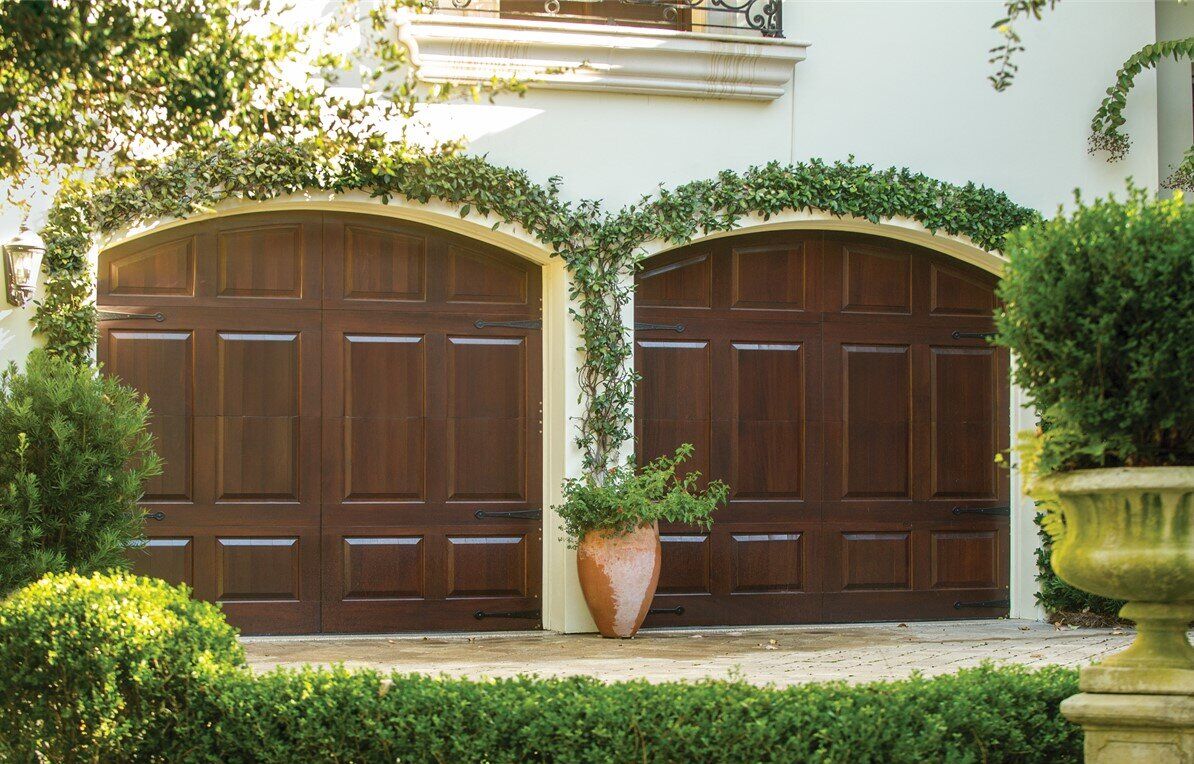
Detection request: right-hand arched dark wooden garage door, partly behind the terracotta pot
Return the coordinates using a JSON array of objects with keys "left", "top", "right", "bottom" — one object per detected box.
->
[{"left": 635, "top": 233, "right": 1009, "bottom": 626}]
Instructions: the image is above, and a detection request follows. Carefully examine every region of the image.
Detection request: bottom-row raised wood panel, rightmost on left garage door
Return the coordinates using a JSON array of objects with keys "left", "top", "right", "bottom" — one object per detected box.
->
[{"left": 447, "top": 535, "right": 528, "bottom": 597}]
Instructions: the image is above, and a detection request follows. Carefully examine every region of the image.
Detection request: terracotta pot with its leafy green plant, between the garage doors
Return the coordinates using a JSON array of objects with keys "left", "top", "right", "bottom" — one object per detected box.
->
[{"left": 555, "top": 444, "right": 730, "bottom": 639}]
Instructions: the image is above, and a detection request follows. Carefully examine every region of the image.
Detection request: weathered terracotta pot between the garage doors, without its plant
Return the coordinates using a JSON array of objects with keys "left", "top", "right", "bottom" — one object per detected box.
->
[{"left": 577, "top": 523, "right": 660, "bottom": 639}]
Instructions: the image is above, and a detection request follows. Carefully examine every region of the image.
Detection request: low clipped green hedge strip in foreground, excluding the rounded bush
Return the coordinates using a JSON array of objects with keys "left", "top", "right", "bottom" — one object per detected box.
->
[{"left": 168, "top": 666, "right": 1081, "bottom": 764}]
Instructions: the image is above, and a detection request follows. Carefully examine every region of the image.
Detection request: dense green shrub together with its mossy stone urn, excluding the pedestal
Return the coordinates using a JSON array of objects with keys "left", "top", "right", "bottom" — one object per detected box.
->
[{"left": 997, "top": 186, "right": 1194, "bottom": 694}]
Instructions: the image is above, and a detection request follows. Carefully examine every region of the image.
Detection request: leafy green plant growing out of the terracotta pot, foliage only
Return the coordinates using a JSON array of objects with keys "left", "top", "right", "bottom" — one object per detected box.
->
[{"left": 555, "top": 443, "right": 730, "bottom": 546}]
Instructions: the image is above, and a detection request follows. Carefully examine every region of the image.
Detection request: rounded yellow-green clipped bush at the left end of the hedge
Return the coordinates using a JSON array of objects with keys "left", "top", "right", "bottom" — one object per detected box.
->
[{"left": 0, "top": 573, "right": 245, "bottom": 763}]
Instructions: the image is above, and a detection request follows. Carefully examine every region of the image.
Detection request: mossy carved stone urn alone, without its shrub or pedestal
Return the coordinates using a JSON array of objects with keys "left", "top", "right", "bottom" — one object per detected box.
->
[{"left": 1038, "top": 467, "right": 1194, "bottom": 694}]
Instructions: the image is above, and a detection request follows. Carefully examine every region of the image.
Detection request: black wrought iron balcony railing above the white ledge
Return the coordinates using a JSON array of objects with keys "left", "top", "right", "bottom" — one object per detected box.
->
[{"left": 433, "top": 0, "right": 783, "bottom": 37}]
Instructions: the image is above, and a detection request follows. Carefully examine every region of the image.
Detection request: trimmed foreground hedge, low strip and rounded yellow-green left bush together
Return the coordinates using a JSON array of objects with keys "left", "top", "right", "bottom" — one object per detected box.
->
[{"left": 0, "top": 574, "right": 1081, "bottom": 764}]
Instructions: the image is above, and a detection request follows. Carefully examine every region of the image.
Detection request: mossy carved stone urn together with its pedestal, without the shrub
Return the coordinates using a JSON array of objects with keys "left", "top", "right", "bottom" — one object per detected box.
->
[{"left": 1035, "top": 467, "right": 1194, "bottom": 764}]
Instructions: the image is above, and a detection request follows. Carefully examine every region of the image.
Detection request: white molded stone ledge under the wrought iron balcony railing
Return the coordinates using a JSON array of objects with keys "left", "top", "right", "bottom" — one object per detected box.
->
[{"left": 411, "top": 14, "right": 808, "bottom": 100}]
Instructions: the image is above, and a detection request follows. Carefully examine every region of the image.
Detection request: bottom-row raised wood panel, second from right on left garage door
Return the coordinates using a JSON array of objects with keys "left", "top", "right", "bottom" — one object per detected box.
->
[{"left": 343, "top": 536, "right": 426, "bottom": 599}]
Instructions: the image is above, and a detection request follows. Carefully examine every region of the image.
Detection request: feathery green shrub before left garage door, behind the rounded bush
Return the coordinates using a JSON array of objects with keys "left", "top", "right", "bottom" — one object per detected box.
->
[{"left": 0, "top": 351, "right": 161, "bottom": 594}]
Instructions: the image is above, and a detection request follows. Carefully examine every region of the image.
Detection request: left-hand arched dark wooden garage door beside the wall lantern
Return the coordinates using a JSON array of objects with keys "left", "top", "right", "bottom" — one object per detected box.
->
[{"left": 99, "top": 212, "right": 542, "bottom": 634}]
